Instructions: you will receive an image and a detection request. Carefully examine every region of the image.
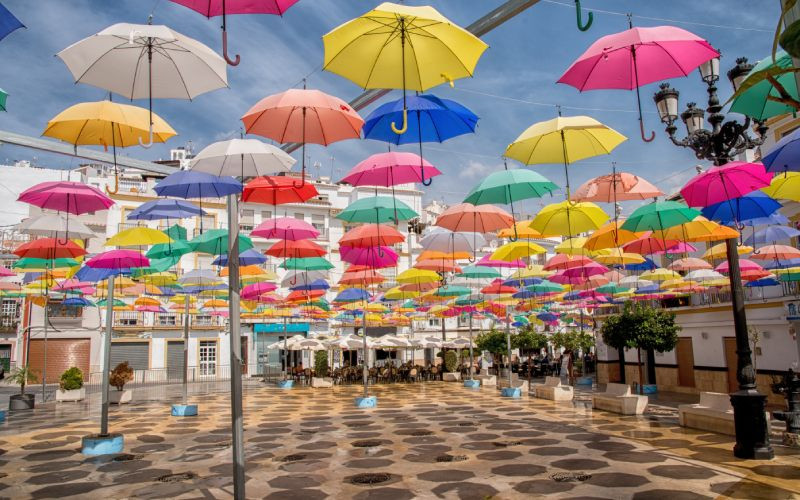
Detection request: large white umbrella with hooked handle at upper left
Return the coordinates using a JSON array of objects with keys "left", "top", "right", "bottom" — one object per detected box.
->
[{"left": 57, "top": 23, "right": 228, "bottom": 147}]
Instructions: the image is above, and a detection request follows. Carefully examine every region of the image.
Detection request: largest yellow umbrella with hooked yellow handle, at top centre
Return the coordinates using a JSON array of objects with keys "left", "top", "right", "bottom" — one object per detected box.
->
[{"left": 322, "top": 2, "right": 488, "bottom": 134}]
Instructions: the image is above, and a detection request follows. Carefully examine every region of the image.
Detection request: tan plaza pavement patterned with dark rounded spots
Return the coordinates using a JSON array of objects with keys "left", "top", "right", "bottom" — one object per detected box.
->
[{"left": 0, "top": 382, "right": 800, "bottom": 500}]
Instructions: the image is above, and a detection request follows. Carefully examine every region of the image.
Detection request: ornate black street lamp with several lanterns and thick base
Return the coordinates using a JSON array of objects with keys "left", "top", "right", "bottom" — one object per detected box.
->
[{"left": 653, "top": 58, "right": 774, "bottom": 459}]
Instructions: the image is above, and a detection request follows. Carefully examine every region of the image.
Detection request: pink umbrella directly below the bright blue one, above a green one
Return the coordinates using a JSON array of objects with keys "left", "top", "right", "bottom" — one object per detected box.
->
[{"left": 340, "top": 151, "right": 442, "bottom": 187}]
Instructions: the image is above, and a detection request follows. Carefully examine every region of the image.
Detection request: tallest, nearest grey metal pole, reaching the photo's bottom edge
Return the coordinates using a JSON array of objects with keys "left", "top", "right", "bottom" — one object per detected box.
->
[{"left": 228, "top": 194, "right": 245, "bottom": 500}]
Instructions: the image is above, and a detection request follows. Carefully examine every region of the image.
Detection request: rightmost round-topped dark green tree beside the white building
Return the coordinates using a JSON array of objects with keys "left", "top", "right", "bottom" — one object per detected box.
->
[{"left": 600, "top": 302, "right": 681, "bottom": 391}]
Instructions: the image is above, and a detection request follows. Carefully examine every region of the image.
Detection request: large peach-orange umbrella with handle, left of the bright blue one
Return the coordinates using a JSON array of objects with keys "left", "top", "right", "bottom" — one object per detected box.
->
[{"left": 242, "top": 88, "right": 364, "bottom": 187}]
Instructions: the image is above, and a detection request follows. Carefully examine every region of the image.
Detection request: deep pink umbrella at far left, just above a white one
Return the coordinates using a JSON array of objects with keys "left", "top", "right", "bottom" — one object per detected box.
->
[{"left": 17, "top": 181, "right": 114, "bottom": 215}]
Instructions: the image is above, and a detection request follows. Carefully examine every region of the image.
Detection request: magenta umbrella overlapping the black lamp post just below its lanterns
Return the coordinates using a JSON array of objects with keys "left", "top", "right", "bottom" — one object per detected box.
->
[{"left": 681, "top": 161, "right": 772, "bottom": 207}]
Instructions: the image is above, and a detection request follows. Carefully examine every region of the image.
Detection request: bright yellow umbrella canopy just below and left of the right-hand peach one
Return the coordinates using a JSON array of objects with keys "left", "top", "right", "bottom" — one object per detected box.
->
[{"left": 531, "top": 200, "right": 608, "bottom": 236}]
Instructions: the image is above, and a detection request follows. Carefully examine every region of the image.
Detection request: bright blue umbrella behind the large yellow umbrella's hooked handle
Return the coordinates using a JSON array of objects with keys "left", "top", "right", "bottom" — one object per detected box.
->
[{"left": 363, "top": 94, "right": 478, "bottom": 145}]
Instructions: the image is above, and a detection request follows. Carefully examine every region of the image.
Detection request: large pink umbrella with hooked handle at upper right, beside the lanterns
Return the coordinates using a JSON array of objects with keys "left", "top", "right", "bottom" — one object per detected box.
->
[{"left": 558, "top": 23, "right": 719, "bottom": 142}]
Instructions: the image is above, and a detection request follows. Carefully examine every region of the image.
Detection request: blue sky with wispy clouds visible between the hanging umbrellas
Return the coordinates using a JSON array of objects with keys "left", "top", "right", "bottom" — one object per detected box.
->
[{"left": 0, "top": 0, "right": 779, "bottom": 212}]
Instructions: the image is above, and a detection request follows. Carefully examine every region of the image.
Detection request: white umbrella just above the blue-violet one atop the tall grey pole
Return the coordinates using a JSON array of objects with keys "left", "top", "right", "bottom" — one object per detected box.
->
[{"left": 191, "top": 139, "right": 296, "bottom": 179}]
